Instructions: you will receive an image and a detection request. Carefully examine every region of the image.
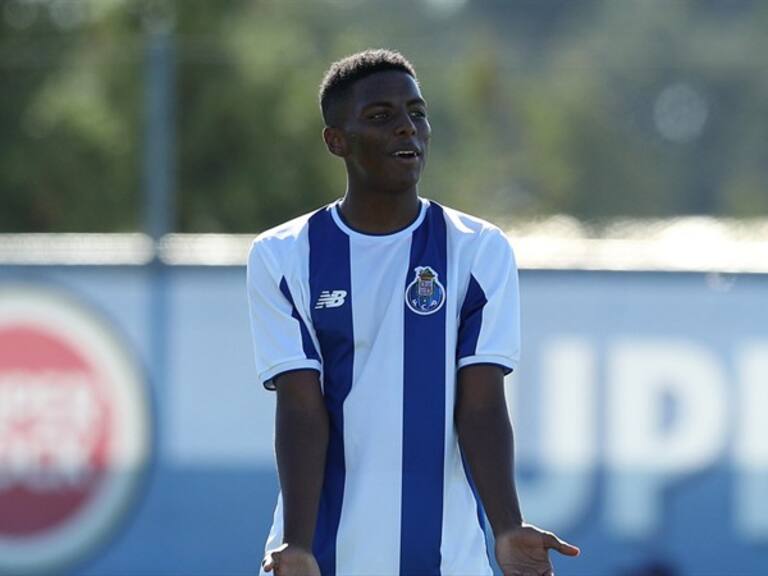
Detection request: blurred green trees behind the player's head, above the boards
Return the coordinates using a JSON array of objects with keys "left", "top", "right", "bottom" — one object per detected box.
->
[{"left": 0, "top": 0, "right": 768, "bottom": 232}]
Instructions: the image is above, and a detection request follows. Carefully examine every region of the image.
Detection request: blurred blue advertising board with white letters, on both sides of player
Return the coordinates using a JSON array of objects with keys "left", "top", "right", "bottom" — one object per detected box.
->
[{"left": 0, "top": 265, "right": 768, "bottom": 576}]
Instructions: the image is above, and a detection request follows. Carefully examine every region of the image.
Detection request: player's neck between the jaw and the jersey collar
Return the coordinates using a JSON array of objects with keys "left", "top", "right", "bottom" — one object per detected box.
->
[{"left": 339, "top": 186, "right": 420, "bottom": 234}]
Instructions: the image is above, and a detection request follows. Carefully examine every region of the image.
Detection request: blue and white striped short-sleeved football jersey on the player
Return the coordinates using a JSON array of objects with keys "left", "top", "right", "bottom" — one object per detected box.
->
[{"left": 247, "top": 199, "right": 520, "bottom": 575}]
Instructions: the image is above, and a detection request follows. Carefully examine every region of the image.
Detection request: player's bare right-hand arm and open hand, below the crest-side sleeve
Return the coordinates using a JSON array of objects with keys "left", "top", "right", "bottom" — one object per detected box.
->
[{"left": 455, "top": 364, "right": 579, "bottom": 576}]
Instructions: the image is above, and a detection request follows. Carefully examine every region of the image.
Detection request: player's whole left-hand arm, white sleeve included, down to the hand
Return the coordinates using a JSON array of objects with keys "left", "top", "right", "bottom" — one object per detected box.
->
[{"left": 247, "top": 241, "right": 328, "bottom": 576}]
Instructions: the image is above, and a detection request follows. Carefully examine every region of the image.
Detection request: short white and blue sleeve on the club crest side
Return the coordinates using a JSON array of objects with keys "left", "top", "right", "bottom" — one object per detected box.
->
[{"left": 456, "top": 228, "right": 520, "bottom": 374}]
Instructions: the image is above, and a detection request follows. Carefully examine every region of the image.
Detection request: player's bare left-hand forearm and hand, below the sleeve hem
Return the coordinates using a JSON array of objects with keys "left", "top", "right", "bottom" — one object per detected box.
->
[{"left": 264, "top": 370, "right": 328, "bottom": 576}]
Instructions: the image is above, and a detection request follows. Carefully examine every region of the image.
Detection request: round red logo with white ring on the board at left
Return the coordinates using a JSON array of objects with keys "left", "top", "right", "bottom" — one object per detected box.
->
[{"left": 0, "top": 288, "right": 149, "bottom": 573}]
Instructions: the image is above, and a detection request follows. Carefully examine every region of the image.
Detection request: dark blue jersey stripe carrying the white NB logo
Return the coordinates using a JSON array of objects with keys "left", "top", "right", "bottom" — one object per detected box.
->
[{"left": 309, "top": 209, "right": 354, "bottom": 576}]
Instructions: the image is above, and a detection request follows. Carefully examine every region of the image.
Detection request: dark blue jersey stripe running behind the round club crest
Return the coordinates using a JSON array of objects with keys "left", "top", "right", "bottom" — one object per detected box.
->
[{"left": 400, "top": 202, "right": 450, "bottom": 576}]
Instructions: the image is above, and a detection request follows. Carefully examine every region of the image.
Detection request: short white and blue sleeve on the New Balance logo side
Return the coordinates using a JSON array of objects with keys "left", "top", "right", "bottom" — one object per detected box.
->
[{"left": 247, "top": 242, "right": 322, "bottom": 390}]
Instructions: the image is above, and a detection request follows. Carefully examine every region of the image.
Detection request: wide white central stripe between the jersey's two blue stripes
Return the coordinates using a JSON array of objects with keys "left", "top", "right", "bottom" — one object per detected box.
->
[{"left": 336, "top": 239, "right": 410, "bottom": 575}]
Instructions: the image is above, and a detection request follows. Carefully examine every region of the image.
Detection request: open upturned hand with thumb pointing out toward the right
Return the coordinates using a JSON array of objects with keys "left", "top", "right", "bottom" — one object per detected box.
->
[{"left": 496, "top": 524, "right": 581, "bottom": 576}]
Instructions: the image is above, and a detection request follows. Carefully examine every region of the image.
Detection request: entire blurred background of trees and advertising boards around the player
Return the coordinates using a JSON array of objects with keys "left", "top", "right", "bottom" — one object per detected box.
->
[{"left": 0, "top": 0, "right": 768, "bottom": 576}]
